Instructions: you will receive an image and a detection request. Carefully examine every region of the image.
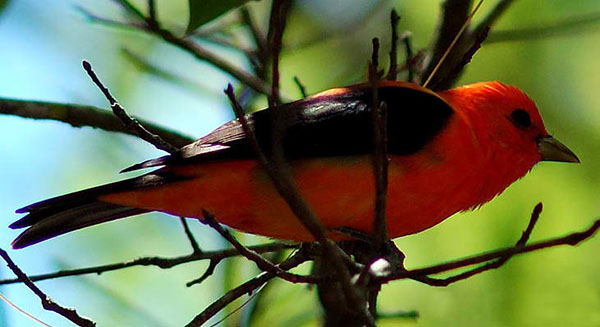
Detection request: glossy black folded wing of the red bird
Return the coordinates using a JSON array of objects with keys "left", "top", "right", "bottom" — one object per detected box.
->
[{"left": 126, "top": 85, "right": 453, "bottom": 171}]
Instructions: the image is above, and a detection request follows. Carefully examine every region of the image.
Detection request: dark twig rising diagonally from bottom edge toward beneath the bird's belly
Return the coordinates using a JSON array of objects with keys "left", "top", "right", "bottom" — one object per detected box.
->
[{"left": 186, "top": 250, "right": 309, "bottom": 327}]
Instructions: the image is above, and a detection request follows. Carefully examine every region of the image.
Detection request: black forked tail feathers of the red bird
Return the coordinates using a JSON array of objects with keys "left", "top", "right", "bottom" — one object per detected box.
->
[{"left": 9, "top": 178, "right": 149, "bottom": 249}]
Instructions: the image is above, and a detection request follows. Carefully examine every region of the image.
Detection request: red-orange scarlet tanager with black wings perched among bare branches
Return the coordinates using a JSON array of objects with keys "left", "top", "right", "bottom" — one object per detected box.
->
[{"left": 10, "top": 82, "right": 579, "bottom": 248}]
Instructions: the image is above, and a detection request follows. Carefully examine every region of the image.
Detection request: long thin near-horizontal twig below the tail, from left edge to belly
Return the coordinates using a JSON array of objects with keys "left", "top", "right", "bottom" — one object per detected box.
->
[{"left": 0, "top": 243, "right": 294, "bottom": 285}]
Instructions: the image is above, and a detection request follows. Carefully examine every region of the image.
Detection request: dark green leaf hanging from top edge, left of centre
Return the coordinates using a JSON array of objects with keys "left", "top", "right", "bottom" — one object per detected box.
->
[{"left": 187, "top": 0, "right": 249, "bottom": 33}]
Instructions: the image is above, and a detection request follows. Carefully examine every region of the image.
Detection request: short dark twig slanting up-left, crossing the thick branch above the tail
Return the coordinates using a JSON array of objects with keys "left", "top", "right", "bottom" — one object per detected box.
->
[{"left": 83, "top": 60, "right": 179, "bottom": 153}]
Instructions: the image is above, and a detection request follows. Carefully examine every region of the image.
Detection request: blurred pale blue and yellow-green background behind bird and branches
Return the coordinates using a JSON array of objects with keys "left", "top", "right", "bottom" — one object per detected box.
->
[{"left": 0, "top": 0, "right": 600, "bottom": 326}]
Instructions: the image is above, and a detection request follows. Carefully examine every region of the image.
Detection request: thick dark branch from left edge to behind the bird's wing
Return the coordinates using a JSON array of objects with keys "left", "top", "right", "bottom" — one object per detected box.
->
[{"left": 0, "top": 98, "right": 194, "bottom": 147}]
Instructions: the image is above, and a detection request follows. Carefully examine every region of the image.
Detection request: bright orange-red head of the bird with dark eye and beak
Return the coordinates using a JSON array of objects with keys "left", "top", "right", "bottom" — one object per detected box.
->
[{"left": 440, "top": 82, "right": 579, "bottom": 166}]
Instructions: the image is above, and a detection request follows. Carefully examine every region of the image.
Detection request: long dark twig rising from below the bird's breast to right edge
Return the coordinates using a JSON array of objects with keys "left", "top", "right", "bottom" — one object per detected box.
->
[{"left": 377, "top": 219, "right": 600, "bottom": 283}]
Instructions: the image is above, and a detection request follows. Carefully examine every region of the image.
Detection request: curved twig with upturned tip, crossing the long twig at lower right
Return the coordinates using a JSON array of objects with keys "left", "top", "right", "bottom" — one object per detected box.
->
[{"left": 414, "top": 203, "right": 543, "bottom": 287}]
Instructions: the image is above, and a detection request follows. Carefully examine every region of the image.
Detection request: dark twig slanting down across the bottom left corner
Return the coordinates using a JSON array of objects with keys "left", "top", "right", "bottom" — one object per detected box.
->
[{"left": 0, "top": 249, "right": 96, "bottom": 327}]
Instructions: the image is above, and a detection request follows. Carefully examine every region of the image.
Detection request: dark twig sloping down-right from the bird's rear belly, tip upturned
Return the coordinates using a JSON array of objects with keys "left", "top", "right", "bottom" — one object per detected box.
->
[{"left": 201, "top": 210, "right": 320, "bottom": 283}]
